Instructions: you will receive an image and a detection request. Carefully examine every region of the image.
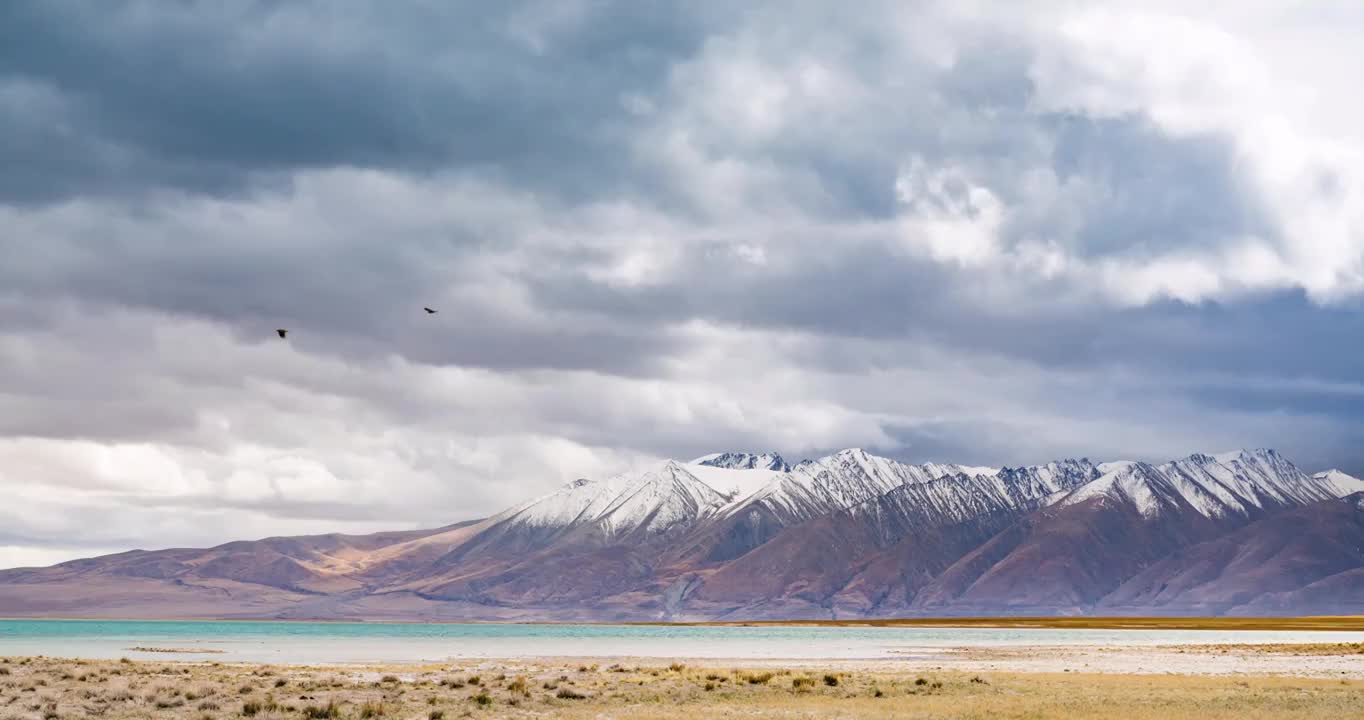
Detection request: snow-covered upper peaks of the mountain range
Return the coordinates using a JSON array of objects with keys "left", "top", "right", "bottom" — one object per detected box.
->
[{"left": 471, "top": 449, "right": 1347, "bottom": 561}]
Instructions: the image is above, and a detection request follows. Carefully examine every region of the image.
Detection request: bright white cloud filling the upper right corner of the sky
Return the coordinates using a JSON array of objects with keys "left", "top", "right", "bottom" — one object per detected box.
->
[{"left": 1031, "top": 5, "right": 1364, "bottom": 303}]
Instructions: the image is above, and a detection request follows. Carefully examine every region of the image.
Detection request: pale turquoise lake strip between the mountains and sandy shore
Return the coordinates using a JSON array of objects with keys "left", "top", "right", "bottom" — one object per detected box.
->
[{"left": 0, "top": 620, "right": 1364, "bottom": 664}]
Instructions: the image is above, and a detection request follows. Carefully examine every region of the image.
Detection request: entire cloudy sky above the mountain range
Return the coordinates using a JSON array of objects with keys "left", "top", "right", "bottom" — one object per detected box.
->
[{"left": 0, "top": 0, "right": 1364, "bottom": 567}]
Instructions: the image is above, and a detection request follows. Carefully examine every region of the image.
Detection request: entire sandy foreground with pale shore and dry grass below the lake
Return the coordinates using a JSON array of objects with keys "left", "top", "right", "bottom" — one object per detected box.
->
[{"left": 0, "top": 645, "right": 1364, "bottom": 720}]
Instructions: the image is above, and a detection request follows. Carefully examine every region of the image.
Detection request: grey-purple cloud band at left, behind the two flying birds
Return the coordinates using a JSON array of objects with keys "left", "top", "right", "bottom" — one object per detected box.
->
[{"left": 0, "top": 193, "right": 678, "bottom": 375}]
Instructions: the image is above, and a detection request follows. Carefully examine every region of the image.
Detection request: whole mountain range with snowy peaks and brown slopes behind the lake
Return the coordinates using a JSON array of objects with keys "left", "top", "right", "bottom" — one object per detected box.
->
[{"left": 0, "top": 449, "right": 1364, "bottom": 620}]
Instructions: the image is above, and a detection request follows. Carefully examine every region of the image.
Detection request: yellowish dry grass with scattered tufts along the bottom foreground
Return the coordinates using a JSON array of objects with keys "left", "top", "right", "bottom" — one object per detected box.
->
[{"left": 0, "top": 659, "right": 1364, "bottom": 720}]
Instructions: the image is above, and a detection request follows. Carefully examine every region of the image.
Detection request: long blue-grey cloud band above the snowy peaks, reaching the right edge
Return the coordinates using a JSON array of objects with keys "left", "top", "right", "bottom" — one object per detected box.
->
[{"left": 518, "top": 229, "right": 1364, "bottom": 382}]
